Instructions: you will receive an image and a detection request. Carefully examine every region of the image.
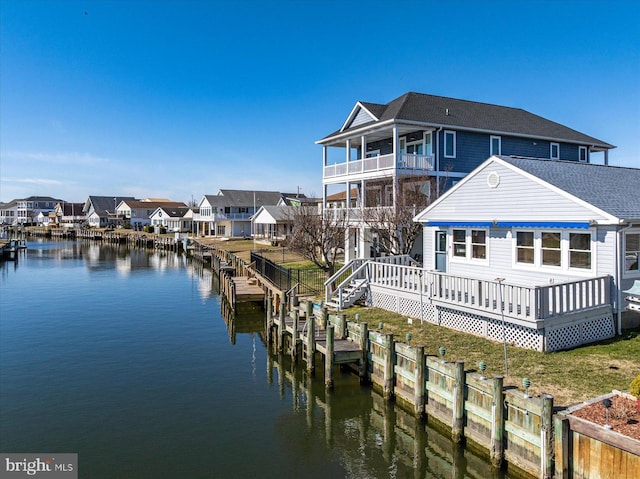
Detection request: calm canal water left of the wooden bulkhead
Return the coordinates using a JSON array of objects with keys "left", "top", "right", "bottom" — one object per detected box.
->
[{"left": 0, "top": 241, "right": 509, "bottom": 479}]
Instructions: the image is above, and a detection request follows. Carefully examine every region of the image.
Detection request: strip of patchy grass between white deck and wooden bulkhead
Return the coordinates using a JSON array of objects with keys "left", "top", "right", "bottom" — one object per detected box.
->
[{"left": 344, "top": 307, "right": 640, "bottom": 406}]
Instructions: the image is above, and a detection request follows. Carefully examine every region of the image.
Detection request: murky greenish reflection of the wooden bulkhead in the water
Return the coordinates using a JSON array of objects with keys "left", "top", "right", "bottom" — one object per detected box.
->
[{"left": 225, "top": 315, "right": 516, "bottom": 479}]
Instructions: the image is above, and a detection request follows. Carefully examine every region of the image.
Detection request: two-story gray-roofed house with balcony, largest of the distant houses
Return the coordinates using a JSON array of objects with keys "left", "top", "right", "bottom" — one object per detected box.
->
[{"left": 194, "top": 190, "right": 284, "bottom": 237}]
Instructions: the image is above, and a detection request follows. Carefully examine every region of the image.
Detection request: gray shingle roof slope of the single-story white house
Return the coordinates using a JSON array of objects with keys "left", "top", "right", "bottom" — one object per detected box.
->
[{"left": 499, "top": 156, "right": 640, "bottom": 220}]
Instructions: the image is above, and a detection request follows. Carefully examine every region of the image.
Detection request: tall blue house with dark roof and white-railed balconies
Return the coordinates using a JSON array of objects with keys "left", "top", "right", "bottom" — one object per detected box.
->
[{"left": 316, "top": 93, "right": 614, "bottom": 261}]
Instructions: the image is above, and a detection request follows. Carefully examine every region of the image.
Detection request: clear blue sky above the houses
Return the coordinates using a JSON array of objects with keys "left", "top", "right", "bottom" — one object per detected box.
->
[{"left": 0, "top": 0, "right": 640, "bottom": 202}]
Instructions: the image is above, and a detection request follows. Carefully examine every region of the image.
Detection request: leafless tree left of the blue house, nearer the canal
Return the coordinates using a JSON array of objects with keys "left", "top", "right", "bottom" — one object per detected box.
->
[{"left": 287, "top": 206, "right": 347, "bottom": 277}]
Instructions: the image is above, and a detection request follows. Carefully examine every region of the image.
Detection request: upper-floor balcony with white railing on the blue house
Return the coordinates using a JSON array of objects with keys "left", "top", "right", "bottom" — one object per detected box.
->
[{"left": 323, "top": 153, "right": 433, "bottom": 183}]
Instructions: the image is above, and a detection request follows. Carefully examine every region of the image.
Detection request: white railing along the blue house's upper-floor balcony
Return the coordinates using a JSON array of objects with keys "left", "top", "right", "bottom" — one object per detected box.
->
[{"left": 324, "top": 153, "right": 433, "bottom": 178}]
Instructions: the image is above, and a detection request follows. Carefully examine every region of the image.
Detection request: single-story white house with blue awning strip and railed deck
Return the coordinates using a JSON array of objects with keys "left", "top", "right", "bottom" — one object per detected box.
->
[{"left": 328, "top": 156, "right": 640, "bottom": 351}]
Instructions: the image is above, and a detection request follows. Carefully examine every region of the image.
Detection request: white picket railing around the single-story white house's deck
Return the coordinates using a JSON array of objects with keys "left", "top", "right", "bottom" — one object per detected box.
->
[{"left": 327, "top": 258, "right": 611, "bottom": 322}]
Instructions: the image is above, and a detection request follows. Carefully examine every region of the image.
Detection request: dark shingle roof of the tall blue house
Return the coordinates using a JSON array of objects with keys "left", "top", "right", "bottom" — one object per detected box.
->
[{"left": 317, "top": 92, "right": 615, "bottom": 149}]
